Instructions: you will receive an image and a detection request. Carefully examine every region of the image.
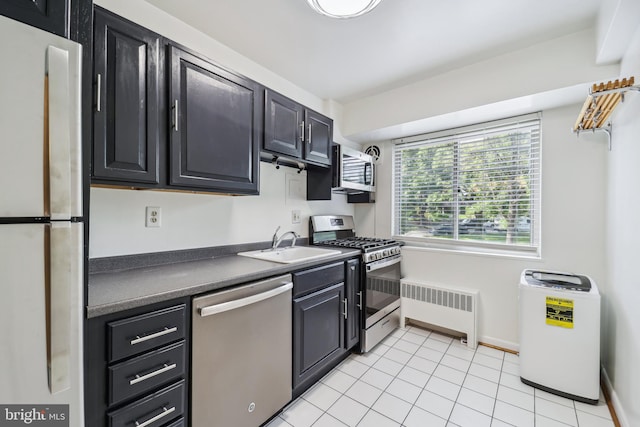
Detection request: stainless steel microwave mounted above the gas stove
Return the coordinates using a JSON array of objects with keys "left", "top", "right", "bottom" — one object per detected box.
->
[{"left": 333, "top": 145, "right": 376, "bottom": 194}]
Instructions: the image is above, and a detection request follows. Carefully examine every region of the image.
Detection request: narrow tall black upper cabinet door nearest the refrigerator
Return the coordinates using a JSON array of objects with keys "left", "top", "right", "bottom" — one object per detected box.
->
[{"left": 93, "top": 9, "right": 161, "bottom": 184}]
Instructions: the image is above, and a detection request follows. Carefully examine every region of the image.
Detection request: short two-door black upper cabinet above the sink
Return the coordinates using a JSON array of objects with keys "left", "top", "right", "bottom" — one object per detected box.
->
[{"left": 263, "top": 89, "right": 333, "bottom": 166}]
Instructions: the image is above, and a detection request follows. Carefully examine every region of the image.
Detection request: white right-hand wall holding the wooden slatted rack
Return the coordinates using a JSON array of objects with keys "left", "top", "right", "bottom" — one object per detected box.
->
[{"left": 601, "top": 26, "right": 640, "bottom": 427}]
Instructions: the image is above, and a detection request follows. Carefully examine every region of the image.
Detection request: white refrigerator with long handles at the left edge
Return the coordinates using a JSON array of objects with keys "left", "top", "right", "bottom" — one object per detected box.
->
[{"left": 0, "top": 16, "right": 84, "bottom": 427}]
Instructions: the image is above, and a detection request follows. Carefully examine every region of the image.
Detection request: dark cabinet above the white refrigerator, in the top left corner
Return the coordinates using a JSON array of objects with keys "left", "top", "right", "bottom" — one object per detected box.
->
[{"left": 0, "top": 0, "right": 69, "bottom": 37}]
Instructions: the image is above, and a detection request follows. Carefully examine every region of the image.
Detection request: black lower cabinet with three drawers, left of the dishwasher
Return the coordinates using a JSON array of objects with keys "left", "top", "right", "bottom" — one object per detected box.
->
[{"left": 85, "top": 298, "right": 191, "bottom": 427}]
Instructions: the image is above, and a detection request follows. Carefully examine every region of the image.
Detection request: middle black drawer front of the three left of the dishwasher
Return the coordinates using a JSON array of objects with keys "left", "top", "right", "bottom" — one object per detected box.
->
[{"left": 109, "top": 341, "right": 185, "bottom": 405}]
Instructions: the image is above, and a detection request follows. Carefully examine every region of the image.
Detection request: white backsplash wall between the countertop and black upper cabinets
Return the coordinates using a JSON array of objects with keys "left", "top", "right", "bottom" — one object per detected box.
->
[{"left": 89, "top": 163, "right": 353, "bottom": 258}]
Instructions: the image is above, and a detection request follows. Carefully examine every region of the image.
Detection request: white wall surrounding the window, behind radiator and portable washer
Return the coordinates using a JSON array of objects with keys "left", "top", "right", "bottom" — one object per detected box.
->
[{"left": 356, "top": 104, "right": 608, "bottom": 350}]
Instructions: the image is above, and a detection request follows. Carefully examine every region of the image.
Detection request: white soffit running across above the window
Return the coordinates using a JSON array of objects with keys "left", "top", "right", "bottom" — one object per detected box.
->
[{"left": 343, "top": 30, "right": 619, "bottom": 140}]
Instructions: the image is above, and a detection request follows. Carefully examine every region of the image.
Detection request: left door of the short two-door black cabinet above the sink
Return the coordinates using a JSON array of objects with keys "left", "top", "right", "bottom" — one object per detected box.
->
[{"left": 264, "top": 89, "right": 304, "bottom": 159}]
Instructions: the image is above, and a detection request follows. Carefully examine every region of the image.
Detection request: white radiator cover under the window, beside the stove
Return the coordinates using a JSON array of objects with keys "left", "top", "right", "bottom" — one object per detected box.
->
[{"left": 400, "top": 279, "right": 478, "bottom": 348}]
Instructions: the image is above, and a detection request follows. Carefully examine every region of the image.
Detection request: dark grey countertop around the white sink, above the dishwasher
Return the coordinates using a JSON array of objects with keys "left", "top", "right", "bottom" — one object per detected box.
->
[{"left": 87, "top": 248, "right": 360, "bottom": 318}]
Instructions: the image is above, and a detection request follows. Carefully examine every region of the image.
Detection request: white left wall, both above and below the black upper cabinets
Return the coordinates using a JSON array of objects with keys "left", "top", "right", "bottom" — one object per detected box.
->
[{"left": 89, "top": 0, "right": 353, "bottom": 258}]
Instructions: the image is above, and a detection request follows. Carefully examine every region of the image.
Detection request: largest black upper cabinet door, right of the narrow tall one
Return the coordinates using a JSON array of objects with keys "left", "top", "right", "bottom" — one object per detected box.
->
[{"left": 169, "top": 46, "right": 263, "bottom": 194}]
